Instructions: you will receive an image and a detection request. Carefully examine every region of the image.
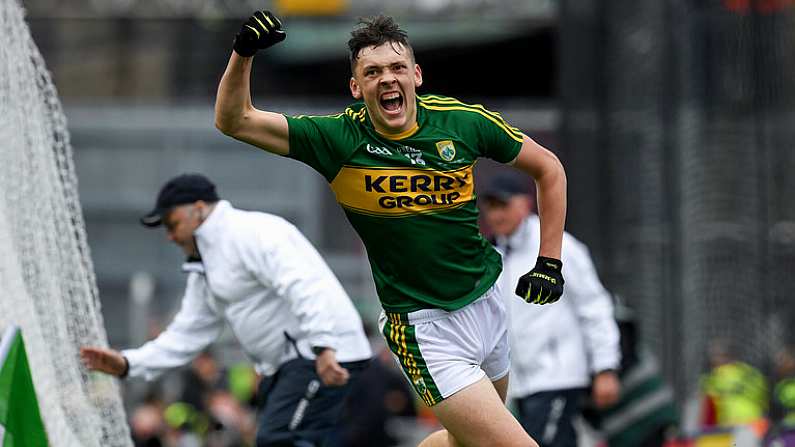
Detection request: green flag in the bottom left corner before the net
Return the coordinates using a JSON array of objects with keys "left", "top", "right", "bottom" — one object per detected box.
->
[{"left": 0, "top": 327, "right": 47, "bottom": 447}]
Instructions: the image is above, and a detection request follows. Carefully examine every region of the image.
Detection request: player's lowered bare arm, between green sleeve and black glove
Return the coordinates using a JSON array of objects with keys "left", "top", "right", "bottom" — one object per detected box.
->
[{"left": 510, "top": 136, "right": 566, "bottom": 259}]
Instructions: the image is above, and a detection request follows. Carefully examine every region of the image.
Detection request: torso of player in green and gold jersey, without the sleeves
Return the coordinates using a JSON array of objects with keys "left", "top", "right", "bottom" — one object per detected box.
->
[{"left": 320, "top": 102, "right": 500, "bottom": 312}]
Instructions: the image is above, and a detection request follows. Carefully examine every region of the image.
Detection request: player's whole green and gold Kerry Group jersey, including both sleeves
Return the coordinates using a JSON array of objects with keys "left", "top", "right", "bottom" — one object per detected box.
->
[{"left": 287, "top": 95, "right": 522, "bottom": 312}]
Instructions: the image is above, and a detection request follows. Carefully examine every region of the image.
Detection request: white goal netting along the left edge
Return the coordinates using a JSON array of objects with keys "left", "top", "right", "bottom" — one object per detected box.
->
[{"left": 0, "top": 0, "right": 131, "bottom": 447}]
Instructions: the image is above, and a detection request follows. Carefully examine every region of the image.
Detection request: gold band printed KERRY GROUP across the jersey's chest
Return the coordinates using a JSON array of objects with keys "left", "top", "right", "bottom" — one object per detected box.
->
[{"left": 331, "top": 164, "right": 475, "bottom": 217}]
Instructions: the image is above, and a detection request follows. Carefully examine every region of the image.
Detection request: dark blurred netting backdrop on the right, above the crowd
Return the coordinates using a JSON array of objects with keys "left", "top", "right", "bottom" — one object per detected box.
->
[{"left": 561, "top": 0, "right": 795, "bottom": 397}]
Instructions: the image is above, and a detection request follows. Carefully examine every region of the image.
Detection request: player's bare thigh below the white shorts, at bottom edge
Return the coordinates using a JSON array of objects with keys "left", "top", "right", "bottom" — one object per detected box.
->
[{"left": 431, "top": 377, "right": 538, "bottom": 447}]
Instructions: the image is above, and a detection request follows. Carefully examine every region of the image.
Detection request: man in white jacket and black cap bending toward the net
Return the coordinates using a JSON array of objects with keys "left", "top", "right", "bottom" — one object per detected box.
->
[{"left": 81, "top": 174, "right": 371, "bottom": 446}]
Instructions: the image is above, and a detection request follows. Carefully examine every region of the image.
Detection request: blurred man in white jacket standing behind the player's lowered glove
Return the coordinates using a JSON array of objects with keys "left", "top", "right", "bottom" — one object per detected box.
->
[{"left": 479, "top": 175, "right": 621, "bottom": 447}]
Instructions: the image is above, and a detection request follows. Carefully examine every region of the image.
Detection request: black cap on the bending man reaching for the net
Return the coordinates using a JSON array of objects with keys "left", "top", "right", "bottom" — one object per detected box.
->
[{"left": 141, "top": 174, "right": 219, "bottom": 227}]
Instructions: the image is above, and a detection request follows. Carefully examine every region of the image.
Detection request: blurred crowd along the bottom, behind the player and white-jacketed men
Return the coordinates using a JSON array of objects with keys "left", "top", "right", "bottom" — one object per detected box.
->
[{"left": 119, "top": 316, "right": 795, "bottom": 447}]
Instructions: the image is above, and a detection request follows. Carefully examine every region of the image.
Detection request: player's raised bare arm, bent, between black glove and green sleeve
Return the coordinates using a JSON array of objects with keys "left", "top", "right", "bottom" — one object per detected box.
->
[{"left": 215, "top": 51, "right": 290, "bottom": 155}]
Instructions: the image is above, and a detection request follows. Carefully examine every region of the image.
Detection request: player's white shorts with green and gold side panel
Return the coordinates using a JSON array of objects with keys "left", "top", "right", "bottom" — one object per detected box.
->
[{"left": 378, "top": 281, "right": 511, "bottom": 406}]
